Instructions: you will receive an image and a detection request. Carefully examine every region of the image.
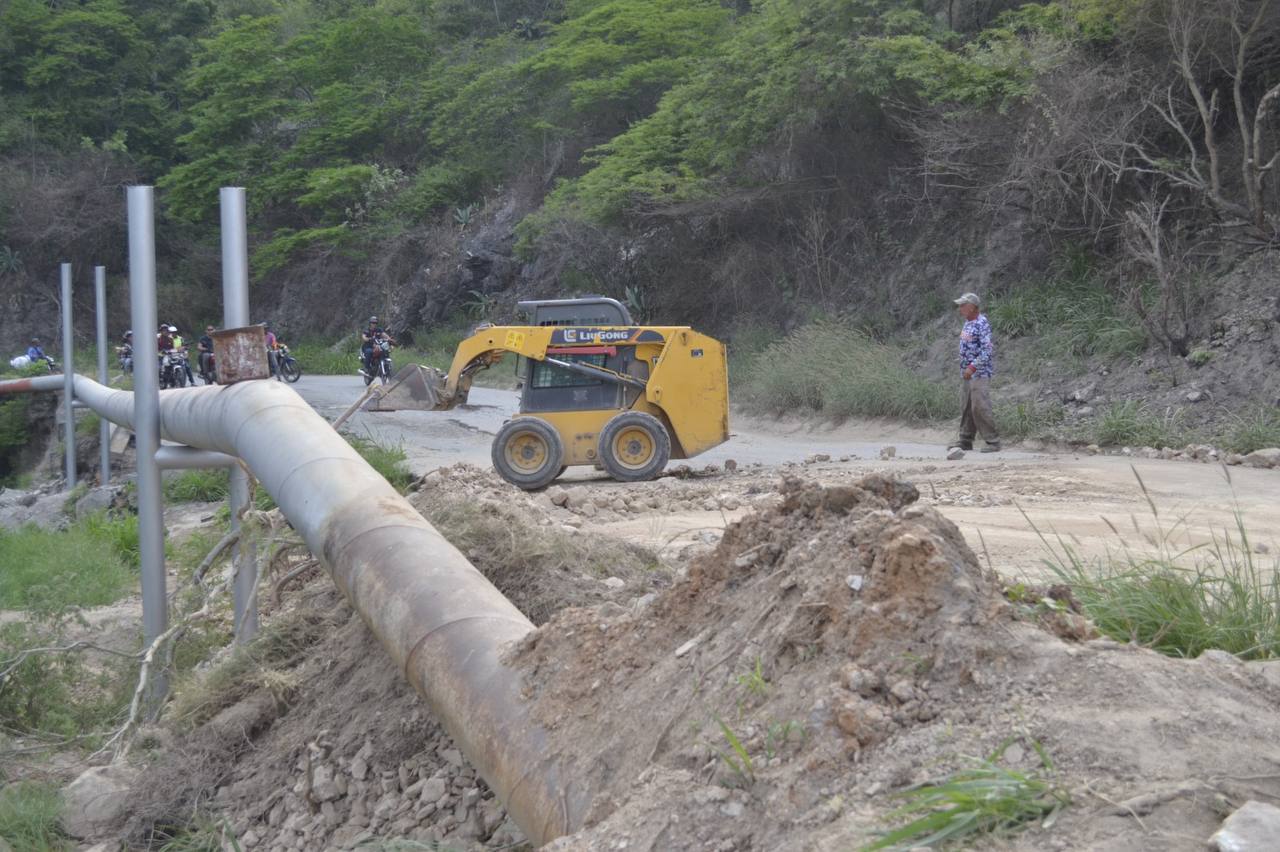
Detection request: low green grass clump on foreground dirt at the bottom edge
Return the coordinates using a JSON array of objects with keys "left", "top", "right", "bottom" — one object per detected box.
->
[{"left": 863, "top": 738, "right": 1071, "bottom": 852}]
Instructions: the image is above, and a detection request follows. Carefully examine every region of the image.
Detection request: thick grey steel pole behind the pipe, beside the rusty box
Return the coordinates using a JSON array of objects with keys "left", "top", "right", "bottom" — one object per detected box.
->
[{"left": 219, "top": 187, "right": 257, "bottom": 642}]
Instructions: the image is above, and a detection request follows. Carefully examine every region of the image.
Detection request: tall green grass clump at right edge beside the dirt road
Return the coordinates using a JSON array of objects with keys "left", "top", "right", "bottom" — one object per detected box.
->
[{"left": 1032, "top": 471, "right": 1280, "bottom": 660}]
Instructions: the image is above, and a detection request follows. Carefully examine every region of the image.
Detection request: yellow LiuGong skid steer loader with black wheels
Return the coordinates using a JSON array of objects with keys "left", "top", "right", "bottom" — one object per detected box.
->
[{"left": 392, "top": 298, "right": 728, "bottom": 490}]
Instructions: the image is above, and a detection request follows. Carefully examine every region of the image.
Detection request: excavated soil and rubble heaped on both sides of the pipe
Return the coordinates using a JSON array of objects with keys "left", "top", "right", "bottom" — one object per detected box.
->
[{"left": 120, "top": 467, "right": 1280, "bottom": 851}]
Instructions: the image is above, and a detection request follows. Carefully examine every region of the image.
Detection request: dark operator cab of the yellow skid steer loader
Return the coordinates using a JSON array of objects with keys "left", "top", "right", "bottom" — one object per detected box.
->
[{"left": 516, "top": 296, "right": 648, "bottom": 412}]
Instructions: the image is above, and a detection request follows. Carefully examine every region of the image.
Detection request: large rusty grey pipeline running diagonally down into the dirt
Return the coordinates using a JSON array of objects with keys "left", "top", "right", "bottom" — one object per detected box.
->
[{"left": 0, "top": 376, "right": 590, "bottom": 844}]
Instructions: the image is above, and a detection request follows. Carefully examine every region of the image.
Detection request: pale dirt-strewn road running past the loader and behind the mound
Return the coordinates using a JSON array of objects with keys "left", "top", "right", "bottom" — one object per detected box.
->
[{"left": 296, "top": 376, "right": 1280, "bottom": 577}]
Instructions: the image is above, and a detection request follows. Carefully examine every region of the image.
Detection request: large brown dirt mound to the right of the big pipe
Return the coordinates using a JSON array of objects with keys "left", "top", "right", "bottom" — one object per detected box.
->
[{"left": 512, "top": 476, "right": 1280, "bottom": 849}]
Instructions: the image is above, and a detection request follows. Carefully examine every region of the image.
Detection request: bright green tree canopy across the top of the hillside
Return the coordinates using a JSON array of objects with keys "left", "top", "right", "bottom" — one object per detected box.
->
[{"left": 0, "top": 0, "right": 1249, "bottom": 295}]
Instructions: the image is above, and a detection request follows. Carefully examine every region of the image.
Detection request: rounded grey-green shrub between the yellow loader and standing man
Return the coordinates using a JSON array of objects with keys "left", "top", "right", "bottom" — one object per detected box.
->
[{"left": 742, "top": 320, "right": 957, "bottom": 420}]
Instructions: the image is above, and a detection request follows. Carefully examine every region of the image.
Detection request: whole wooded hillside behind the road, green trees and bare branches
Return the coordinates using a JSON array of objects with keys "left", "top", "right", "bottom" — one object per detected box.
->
[{"left": 0, "top": 0, "right": 1280, "bottom": 424}]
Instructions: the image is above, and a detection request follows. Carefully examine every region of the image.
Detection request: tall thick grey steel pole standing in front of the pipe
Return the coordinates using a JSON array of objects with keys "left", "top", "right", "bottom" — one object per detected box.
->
[{"left": 125, "top": 187, "right": 169, "bottom": 714}]
